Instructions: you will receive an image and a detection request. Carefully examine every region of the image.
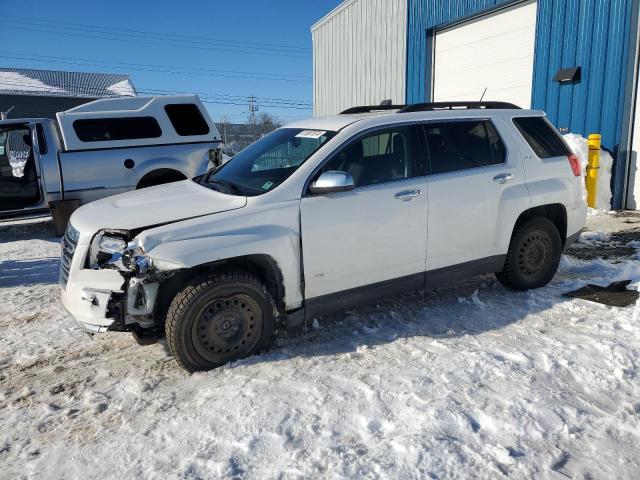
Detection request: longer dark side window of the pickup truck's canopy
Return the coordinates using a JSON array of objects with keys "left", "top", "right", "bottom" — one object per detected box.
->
[{"left": 73, "top": 117, "right": 162, "bottom": 142}]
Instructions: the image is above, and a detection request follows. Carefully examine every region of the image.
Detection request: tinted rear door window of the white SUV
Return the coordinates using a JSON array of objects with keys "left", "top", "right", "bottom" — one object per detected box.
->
[{"left": 424, "top": 120, "right": 506, "bottom": 174}]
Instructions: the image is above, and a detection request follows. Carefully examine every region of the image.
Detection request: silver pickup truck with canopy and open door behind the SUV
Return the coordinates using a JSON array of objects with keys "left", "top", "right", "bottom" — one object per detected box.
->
[{"left": 0, "top": 95, "right": 221, "bottom": 235}]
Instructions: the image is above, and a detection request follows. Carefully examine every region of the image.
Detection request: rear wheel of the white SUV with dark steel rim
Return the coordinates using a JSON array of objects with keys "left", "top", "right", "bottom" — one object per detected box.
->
[{"left": 496, "top": 217, "right": 562, "bottom": 290}]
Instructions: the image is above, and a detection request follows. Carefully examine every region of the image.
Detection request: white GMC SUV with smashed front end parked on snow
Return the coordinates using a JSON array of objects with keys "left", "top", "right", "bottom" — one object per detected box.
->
[{"left": 60, "top": 102, "right": 586, "bottom": 371}]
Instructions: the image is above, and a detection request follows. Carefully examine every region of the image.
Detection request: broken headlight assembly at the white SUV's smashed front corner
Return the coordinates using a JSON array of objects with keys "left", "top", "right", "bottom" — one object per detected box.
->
[{"left": 89, "top": 230, "right": 151, "bottom": 273}]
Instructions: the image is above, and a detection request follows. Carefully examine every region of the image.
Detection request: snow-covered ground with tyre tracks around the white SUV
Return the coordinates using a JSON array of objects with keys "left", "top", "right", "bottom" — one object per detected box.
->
[{"left": 0, "top": 215, "right": 640, "bottom": 479}]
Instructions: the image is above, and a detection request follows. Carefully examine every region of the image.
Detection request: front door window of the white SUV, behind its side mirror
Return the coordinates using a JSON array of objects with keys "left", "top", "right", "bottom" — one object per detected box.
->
[{"left": 321, "top": 126, "right": 424, "bottom": 187}]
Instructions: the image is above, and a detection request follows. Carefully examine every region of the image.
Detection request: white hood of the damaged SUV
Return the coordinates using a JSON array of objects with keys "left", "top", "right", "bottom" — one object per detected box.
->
[{"left": 70, "top": 180, "right": 247, "bottom": 243}]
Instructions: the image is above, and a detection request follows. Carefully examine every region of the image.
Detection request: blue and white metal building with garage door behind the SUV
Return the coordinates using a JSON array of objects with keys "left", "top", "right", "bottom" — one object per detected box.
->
[{"left": 312, "top": 0, "right": 640, "bottom": 208}]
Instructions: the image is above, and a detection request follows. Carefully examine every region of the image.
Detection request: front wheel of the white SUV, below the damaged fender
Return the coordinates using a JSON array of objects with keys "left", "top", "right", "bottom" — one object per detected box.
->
[{"left": 165, "top": 271, "right": 278, "bottom": 372}]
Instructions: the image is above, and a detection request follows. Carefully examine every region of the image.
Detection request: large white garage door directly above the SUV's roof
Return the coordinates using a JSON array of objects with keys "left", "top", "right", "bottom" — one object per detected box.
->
[{"left": 433, "top": 1, "right": 537, "bottom": 108}]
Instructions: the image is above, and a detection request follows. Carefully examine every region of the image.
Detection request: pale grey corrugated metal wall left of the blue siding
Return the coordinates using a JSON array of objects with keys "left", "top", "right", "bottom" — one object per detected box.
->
[{"left": 311, "top": 0, "right": 407, "bottom": 115}]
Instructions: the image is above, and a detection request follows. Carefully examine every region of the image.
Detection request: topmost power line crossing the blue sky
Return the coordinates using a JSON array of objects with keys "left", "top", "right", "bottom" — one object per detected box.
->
[{"left": 3, "top": 15, "right": 311, "bottom": 53}]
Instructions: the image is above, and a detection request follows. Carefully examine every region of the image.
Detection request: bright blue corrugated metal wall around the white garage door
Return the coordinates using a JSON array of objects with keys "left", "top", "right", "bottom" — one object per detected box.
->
[{"left": 407, "top": 0, "right": 633, "bottom": 206}]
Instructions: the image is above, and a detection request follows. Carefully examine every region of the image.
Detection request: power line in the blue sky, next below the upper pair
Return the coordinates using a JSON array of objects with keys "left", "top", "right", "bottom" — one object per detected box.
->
[{"left": 0, "top": 51, "right": 311, "bottom": 83}]
